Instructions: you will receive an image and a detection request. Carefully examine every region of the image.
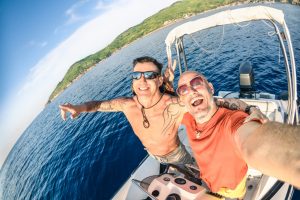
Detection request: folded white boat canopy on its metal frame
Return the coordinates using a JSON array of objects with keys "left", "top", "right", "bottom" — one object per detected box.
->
[{"left": 165, "top": 6, "right": 299, "bottom": 124}]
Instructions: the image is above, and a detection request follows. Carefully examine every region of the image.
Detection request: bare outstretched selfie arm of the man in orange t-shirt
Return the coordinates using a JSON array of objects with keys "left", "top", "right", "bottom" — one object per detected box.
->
[{"left": 236, "top": 122, "right": 300, "bottom": 188}]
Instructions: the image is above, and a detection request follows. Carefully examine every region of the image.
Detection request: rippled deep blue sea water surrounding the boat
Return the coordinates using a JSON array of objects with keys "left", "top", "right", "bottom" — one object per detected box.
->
[{"left": 0, "top": 4, "right": 300, "bottom": 200}]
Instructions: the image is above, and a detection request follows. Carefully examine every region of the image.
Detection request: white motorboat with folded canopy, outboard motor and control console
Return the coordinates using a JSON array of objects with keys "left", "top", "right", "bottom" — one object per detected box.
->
[{"left": 113, "top": 6, "right": 299, "bottom": 200}]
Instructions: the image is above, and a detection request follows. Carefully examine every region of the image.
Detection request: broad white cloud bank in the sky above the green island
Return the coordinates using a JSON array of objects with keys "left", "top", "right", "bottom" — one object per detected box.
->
[{"left": 0, "top": 0, "right": 175, "bottom": 166}]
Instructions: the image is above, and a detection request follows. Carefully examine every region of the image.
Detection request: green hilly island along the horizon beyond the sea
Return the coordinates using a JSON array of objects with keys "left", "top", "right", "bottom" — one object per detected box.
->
[{"left": 47, "top": 0, "right": 299, "bottom": 103}]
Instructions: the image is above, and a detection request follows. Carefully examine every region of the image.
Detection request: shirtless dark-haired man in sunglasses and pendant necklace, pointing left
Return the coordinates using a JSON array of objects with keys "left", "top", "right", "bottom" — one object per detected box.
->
[{"left": 60, "top": 56, "right": 264, "bottom": 164}]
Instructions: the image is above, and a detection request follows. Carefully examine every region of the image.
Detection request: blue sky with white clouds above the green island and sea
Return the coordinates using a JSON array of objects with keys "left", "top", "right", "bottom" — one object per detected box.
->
[{"left": 0, "top": 0, "right": 176, "bottom": 167}]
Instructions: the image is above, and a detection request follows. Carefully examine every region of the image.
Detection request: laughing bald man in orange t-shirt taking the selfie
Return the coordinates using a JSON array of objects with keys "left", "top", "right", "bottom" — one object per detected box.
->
[{"left": 177, "top": 71, "right": 300, "bottom": 198}]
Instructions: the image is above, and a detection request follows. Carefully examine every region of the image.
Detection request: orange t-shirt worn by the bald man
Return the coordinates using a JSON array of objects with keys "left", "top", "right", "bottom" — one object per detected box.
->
[{"left": 182, "top": 108, "right": 248, "bottom": 192}]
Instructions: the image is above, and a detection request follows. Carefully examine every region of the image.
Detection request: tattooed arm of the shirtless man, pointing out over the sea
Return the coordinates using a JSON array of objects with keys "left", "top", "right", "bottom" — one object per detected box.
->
[{"left": 59, "top": 98, "right": 131, "bottom": 120}]
